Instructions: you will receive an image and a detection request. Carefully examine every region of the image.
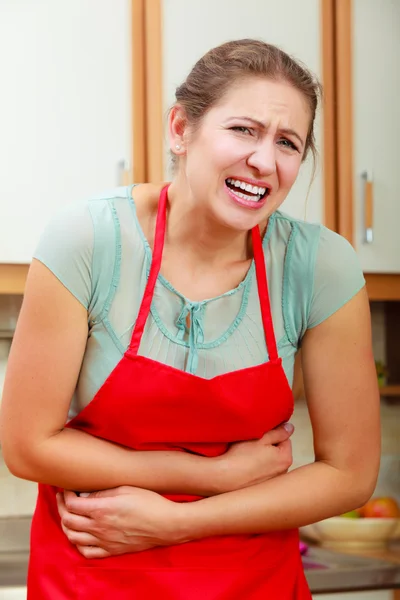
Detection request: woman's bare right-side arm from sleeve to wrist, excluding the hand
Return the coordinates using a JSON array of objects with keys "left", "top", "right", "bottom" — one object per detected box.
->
[{"left": 173, "top": 289, "right": 380, "bottom": 539}]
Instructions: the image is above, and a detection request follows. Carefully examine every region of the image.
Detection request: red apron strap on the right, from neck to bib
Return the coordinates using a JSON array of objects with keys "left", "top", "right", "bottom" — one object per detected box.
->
[{"left": 251, "top": 226, "right": 278, "bottom": 360}]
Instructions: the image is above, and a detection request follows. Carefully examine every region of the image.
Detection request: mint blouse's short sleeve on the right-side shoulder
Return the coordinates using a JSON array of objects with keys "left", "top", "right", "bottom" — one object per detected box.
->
[{"left": 307, "top": 227, "right": 365, "bottom": 329}]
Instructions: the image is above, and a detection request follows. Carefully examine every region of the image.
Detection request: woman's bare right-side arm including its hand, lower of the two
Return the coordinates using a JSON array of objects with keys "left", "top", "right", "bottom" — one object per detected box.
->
[{"left": 59, "top": 289, "right": 380, "bottom": 558}]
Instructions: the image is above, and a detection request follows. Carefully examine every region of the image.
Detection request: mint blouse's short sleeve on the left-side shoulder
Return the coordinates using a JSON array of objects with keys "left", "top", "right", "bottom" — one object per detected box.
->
[{"left": 33, "top": 203, "right": 94, "bottom": 310}]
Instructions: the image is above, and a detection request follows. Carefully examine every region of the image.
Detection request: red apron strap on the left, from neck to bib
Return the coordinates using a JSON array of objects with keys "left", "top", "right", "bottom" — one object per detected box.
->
[{"left": 128, "top": 185, "right": 169, "bottom": 356}]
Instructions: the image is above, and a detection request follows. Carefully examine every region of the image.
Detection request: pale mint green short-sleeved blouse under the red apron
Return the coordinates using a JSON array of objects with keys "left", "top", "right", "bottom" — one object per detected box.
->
[{"left": 34, "top": 186, "right": 365, "bottom": 418}]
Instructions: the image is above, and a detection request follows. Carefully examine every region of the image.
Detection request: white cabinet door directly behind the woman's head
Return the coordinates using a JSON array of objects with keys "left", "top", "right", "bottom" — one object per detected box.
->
[{"left": 162, "top": 0, "right": 323, "bottom": 221}]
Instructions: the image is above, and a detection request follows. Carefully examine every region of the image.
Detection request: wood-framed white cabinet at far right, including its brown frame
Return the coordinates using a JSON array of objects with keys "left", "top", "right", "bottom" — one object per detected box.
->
[{"left": 335, "top": 0, "right": 400, "bottom": 274}]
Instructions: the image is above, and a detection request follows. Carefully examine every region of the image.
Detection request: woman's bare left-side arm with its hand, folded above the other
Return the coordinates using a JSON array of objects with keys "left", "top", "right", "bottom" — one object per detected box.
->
[{"left": 0, "top": 261, "right": 291, "bottom": 496}]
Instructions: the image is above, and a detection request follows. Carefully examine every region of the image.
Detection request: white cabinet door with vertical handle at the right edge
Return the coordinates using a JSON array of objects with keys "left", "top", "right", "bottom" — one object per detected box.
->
[{"left": 353, "top": 0, "right": 400, "bottom": 273}]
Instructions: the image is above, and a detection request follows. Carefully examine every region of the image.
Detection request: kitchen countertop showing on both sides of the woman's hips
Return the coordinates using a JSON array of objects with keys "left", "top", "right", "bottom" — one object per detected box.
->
[{"left": 0, "top": 517, "right": 400, "bottom": 594}]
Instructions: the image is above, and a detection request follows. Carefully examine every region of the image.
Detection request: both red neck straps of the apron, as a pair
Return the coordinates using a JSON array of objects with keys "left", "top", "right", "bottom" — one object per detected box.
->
[{"left": 128, "top": 185, "right": 278, "bottom": 360}]
